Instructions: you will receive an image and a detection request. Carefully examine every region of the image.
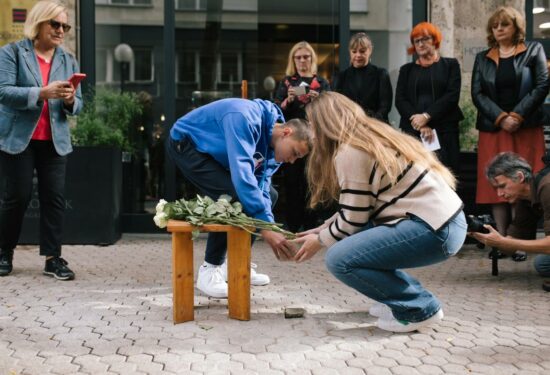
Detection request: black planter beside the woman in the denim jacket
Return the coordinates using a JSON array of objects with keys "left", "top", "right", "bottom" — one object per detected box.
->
[{"left": 19, "top": 147, "right": 122, "bottom": 245}]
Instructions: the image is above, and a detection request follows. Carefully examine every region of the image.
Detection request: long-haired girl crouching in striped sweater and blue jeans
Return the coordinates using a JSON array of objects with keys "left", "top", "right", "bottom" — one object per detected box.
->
[{"left": 295, "top": 92, "right": 466, "bottom": 332}]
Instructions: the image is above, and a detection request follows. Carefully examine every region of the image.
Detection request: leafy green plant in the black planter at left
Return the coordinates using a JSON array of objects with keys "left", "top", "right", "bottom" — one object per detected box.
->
[{"left": 71, "top": 89, "right": 142, "bottom": 152}]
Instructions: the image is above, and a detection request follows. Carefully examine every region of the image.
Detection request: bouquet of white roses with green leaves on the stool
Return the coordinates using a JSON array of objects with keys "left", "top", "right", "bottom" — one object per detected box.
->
[{"left": 153, "top": 195, "right": 296, "bottom": 239}]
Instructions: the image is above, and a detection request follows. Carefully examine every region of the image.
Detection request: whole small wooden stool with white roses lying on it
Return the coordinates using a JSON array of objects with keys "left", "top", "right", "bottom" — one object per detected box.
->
[{"left": 167, "top": 220, "right": 251, "bottom": 324}]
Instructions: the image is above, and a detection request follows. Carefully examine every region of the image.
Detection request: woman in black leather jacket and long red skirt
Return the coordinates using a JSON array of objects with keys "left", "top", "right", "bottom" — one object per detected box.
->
[{"left": 472, "top": 7, "right": 548, "bottom": 260}]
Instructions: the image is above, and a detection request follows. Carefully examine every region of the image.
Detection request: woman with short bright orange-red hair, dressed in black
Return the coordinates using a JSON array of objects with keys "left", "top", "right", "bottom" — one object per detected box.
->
[{"left": 395, "top": 22, "right": 464, "bottom": 173}]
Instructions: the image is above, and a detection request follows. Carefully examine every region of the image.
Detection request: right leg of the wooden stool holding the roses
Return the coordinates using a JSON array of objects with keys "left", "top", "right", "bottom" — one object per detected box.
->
[{"left": 227, "top": 229, "right": 250, "bottom": 320}]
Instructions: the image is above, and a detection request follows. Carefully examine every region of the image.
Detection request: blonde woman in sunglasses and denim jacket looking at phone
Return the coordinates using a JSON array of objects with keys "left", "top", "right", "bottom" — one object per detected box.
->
[{"left": 0, "top": 1, "right": 82, "bottom": 280}]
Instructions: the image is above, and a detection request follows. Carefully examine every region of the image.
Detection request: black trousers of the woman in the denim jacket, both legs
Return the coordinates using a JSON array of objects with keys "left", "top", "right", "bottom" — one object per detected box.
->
[{"left": 0, "top": 141, "right": 67, "bottom": 256}]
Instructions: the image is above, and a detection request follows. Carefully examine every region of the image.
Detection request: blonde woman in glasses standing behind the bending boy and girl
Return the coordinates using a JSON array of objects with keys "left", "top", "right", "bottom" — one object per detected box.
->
[{"left": 275, "top": 41, "right": 330, "bottom": 232}]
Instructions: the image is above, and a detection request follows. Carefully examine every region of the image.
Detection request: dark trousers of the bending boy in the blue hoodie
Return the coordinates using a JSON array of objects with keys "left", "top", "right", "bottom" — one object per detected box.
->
[{"left": 166, "top": 137, "right": 278, "bottom": 265}]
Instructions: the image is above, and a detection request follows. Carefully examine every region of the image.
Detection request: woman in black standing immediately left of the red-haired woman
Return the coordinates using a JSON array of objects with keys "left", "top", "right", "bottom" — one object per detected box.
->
[{"left": 334, "top": 33, "right": 393, "bottom": 122}]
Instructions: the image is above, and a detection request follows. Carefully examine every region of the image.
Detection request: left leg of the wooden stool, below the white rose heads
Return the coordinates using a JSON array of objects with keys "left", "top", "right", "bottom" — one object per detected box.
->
[{"left": 176, "top": 232, "right": 195, "bottom": 324}]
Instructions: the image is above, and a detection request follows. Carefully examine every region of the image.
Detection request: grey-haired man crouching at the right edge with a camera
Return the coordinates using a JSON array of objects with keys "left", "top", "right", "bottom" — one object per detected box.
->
[{"left": 470, "top": 152, "right": 550, "bottom": 291}]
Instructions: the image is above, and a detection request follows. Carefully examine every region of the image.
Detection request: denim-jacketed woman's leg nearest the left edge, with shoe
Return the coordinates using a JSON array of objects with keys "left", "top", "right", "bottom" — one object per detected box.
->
[{"left": 0, "top": 148, "right": 34, "bottom": 276}]
